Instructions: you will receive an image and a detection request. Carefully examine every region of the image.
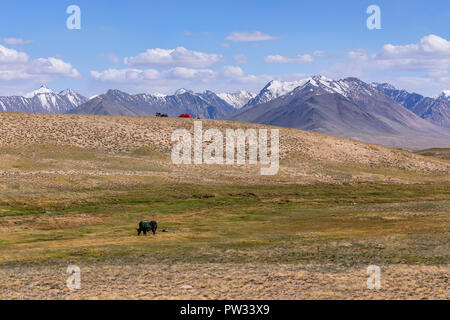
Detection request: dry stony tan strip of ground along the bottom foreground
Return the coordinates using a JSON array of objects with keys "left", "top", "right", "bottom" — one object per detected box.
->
[{"left": 0, "top": 261, "right": 450, "bottom": 299}]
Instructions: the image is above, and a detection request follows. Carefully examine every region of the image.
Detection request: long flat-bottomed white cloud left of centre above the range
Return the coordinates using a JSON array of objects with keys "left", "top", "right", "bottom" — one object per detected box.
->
[{"left": 124, "top": 47, "right": 223, "bottom": 68}]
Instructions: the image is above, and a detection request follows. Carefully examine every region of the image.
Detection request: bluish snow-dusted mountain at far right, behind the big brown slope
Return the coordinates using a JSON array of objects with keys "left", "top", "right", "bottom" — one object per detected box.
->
[{"left": 373, "top": 83, "right": 450, "bottom": 129}]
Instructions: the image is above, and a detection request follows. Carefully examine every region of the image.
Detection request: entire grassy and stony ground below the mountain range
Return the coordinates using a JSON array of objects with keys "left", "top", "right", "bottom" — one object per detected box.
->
[{"left": 0, "top": 113, "right": 450, "bottom": 299}]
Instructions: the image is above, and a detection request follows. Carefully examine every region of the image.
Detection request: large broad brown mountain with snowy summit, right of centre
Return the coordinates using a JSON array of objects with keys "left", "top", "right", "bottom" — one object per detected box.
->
[{"left": 229, "top": 76, "right": 450, "bottom": 149}]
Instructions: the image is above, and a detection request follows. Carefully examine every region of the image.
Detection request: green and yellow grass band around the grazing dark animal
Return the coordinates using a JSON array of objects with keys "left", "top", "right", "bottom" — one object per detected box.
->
[{"left": 0, "top": 184, "right": 450, "bottom": 265}]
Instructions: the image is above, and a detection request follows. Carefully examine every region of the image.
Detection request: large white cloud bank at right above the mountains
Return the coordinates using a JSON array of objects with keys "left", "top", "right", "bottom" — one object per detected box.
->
[{"left": 322, "top": 34, "right": 450, "bottom": 95}]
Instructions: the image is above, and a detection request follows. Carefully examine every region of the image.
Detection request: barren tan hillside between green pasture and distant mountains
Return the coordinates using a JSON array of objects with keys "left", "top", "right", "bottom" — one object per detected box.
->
[{"left": 0, "top": 113, "right": 450, "bottom": 183}]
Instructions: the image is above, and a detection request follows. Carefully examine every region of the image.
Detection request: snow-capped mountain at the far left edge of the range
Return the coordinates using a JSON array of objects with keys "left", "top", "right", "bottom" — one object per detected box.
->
[{"left": 0, "top": 85, "right": 87, "bottom": 113}]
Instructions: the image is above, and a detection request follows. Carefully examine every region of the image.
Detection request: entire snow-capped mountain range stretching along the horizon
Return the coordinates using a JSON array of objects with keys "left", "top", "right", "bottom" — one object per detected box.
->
[{"left": 0, "top": 76, "right": 450, "bottom": 149}]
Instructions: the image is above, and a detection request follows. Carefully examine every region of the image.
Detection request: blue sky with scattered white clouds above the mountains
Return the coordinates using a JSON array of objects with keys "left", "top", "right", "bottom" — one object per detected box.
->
[{"left": 0, "top": 0, "right": 450, "bottom": 96}]
